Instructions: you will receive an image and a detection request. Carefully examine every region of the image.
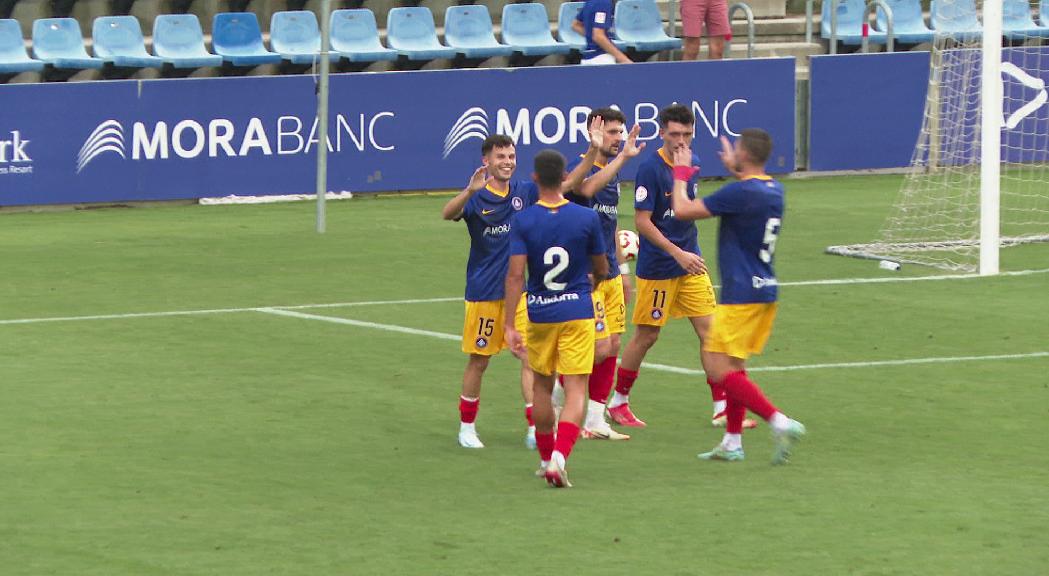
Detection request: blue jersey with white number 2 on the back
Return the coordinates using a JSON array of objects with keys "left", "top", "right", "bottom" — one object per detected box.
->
[{"left": 510, "top": 198, "right": 605, "bottom": 323}]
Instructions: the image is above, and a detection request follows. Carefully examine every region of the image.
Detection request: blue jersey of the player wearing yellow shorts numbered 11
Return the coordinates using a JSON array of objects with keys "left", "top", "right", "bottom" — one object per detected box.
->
[{"left": 634, "top": 148, "right": 701, "bottom": 280}]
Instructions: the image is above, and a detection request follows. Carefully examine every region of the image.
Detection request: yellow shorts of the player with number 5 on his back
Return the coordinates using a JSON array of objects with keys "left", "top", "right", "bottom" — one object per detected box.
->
[{"left": 703, "top": 302, "right": 776, "bottom": 360}]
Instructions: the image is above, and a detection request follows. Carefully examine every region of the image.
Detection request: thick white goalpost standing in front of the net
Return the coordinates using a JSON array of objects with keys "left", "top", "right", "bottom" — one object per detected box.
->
[{"left": 980, "top": 0, "right": 1004, "bottom": 276}]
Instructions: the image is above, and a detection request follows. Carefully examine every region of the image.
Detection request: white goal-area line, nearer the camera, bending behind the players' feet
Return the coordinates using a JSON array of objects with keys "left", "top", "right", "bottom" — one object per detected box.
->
[{"left": 255, "top": 308, "right": 1049, "bottom": 376}]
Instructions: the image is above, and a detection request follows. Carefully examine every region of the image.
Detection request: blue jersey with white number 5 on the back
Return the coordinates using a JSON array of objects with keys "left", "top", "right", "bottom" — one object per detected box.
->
[{"left": 703, "top": 176, "right": 784, "bottom": 304}]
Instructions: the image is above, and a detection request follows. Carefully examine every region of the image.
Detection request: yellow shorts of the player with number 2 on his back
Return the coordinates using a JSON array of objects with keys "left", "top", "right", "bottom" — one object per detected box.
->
[{"left": 528, "top": 318, "right": 595, "bottom": 376}]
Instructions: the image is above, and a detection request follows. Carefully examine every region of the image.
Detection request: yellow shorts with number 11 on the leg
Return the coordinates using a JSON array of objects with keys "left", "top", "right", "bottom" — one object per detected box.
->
[{"left": 633, "top": 274, "right": 718, "bottom": 326}]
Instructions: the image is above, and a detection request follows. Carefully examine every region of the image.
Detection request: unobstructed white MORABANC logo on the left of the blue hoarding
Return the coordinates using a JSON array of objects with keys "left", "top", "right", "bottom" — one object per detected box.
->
[{"left": 77, "top": 111, "right": 395, "bottom": 173}]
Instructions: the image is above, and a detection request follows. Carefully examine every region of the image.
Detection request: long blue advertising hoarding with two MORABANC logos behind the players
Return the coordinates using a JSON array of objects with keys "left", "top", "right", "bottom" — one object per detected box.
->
[{"left": 0, "top": 59, "right": 795, "bottom": 206}]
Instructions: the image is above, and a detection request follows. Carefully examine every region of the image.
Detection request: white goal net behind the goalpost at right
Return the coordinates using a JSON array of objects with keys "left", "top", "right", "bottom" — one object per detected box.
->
[{"left": 827, "top": 0, "right": 1049, "bottom": 272}]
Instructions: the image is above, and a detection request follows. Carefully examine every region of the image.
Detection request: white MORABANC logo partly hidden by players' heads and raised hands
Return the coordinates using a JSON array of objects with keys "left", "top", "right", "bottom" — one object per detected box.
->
[{"left": 443, "top": 99, "right": 748, "bottom": 158}]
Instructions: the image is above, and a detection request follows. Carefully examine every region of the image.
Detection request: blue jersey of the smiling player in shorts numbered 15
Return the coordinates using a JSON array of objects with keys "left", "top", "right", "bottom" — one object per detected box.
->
[{"left": 462, "top": 180, "right": 539, "bottom": 302}]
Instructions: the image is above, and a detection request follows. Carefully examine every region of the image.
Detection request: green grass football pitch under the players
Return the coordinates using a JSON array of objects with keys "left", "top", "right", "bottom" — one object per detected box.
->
[{"left": 0, "top": 176, "right": 1049, "bottom": 576}]
